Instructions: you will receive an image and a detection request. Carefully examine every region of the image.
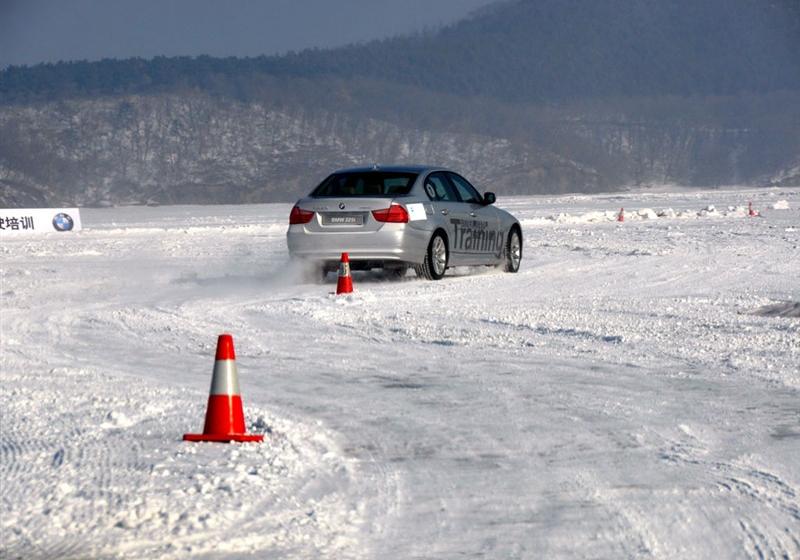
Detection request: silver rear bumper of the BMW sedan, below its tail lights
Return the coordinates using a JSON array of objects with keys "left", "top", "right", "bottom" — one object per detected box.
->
[{"left": 286, "top": 223, "right": 430, "bottom": 264}]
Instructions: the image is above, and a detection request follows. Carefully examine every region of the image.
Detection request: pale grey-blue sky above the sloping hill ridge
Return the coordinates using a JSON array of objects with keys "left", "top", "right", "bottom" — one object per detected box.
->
[{"left": 0, "top": 0, "right": 493, "bottom": 69}]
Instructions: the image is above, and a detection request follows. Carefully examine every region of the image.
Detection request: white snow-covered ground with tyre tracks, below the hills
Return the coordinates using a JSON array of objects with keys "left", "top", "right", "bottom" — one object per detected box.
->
[{"left": 0, "top": 189, "right": 800, "bottom": 559}]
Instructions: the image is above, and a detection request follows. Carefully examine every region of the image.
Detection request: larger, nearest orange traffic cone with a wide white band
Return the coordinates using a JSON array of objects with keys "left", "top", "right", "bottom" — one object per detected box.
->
[{"left": 183, "top": 334, "right": 264, "bottom": 442}]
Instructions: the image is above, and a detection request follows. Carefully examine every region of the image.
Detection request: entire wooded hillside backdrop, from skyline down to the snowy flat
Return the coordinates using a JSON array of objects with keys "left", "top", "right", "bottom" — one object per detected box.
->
[{"left": 0, "top": 0, "right": 800, "bottom": 205}]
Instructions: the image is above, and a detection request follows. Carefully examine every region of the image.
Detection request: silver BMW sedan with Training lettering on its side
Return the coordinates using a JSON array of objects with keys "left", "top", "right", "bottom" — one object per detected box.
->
[{"left": 286, "top": 166, "right": 522, "bottom": 280}]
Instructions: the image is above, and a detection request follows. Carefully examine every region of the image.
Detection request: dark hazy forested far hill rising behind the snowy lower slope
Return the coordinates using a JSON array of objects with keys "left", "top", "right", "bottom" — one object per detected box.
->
[{"left": 0, "top": 0, "right": 800, "bottom": 103}]
